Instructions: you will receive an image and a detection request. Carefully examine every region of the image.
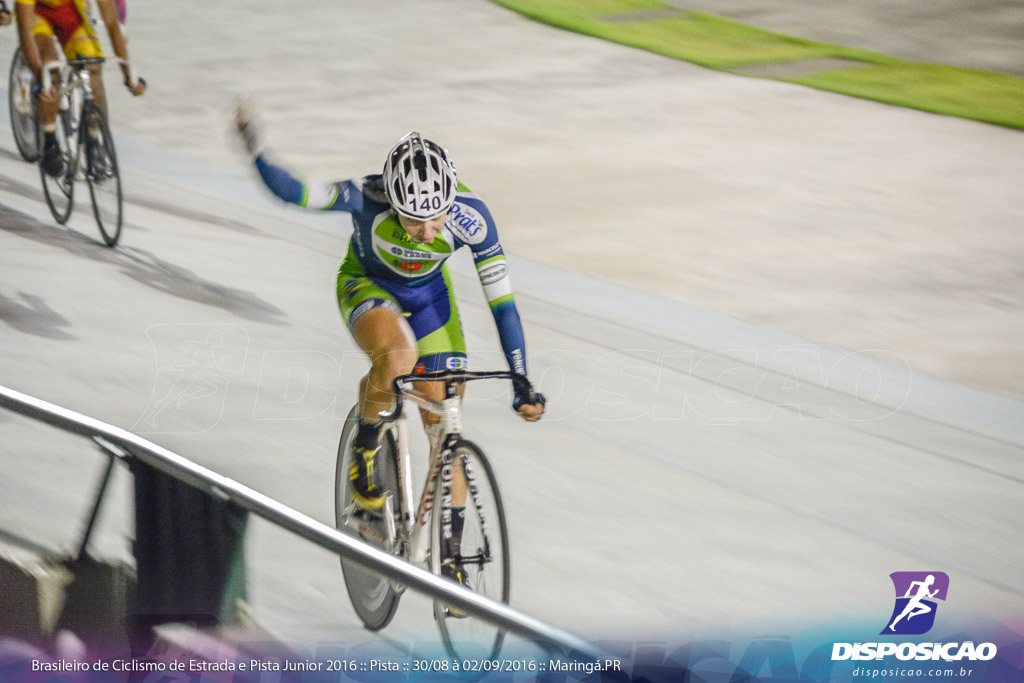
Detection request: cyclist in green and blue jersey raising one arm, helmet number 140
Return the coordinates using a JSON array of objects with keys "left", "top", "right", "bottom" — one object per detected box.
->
[{"left": 236, "top": 108, "right": 544, "bottom": 579}]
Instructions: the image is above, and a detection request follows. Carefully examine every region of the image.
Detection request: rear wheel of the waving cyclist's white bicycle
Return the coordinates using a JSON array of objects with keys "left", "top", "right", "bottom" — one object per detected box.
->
[{"left": 334, "top": 408, "right": 400, "bottom": 631}]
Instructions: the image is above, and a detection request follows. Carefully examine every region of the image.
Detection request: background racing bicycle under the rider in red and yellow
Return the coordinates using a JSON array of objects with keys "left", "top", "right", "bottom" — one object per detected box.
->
[{"left": 36, "top": 57, "right": 123, "bottom": 247}]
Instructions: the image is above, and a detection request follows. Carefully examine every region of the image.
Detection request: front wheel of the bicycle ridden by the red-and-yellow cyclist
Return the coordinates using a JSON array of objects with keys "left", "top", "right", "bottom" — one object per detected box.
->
[{"left": 82, "top": 104, "right": 124, "bottom": 247}]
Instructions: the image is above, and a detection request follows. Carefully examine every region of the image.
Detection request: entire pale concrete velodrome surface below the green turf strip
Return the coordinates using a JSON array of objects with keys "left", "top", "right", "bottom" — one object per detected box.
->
[{"left": 0, "top": 0, "right": 1024, "bottom": 647}]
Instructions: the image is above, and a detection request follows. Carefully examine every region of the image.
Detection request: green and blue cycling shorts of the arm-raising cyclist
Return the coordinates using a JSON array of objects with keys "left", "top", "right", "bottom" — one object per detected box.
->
[{"left": 338, "top": 250, "right": 468, "bottom": 373}]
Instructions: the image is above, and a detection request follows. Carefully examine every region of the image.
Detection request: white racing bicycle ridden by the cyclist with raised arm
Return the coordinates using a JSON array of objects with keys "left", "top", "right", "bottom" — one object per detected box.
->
[{"left": 335, "top": 370, "right": 532, "bottom": 658}]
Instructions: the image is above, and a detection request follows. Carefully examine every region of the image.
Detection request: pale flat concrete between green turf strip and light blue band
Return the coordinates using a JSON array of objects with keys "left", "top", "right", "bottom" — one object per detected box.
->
[{"left": 97, "top": 0, "right": 1024, "bottom": 398}]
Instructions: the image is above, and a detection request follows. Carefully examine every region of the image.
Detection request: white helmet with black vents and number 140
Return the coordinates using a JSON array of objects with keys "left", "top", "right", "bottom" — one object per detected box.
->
[{"left": 383, "top": 131, "right": 459, "bottom": 220}]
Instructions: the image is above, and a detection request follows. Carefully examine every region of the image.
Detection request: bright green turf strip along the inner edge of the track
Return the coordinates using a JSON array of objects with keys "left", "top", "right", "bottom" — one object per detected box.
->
[{"left": 494, "top": 0, "right": 1024, "bottom": 128}]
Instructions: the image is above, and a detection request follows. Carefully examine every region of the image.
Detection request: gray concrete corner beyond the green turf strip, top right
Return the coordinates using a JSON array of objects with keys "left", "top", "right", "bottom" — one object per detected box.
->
[{"left": 667, "top": 0, "right": 1024, "bottom": 76}]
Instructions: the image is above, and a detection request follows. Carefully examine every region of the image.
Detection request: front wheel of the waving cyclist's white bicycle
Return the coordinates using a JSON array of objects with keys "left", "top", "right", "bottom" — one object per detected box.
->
[{"left": 430, "top": 440, "right": 511, "bottom": 659}]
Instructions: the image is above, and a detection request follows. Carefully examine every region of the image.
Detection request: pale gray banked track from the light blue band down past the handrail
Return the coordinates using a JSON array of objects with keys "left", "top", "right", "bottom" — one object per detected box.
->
[{"left": 0, "top": 152, "right": 1024, "bottom": 652}]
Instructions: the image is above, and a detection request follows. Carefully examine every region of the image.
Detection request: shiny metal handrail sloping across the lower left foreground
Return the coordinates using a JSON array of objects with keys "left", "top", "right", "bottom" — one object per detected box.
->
[{"left": 0, "top": 385, "right": 600, "bottom": 659}]
